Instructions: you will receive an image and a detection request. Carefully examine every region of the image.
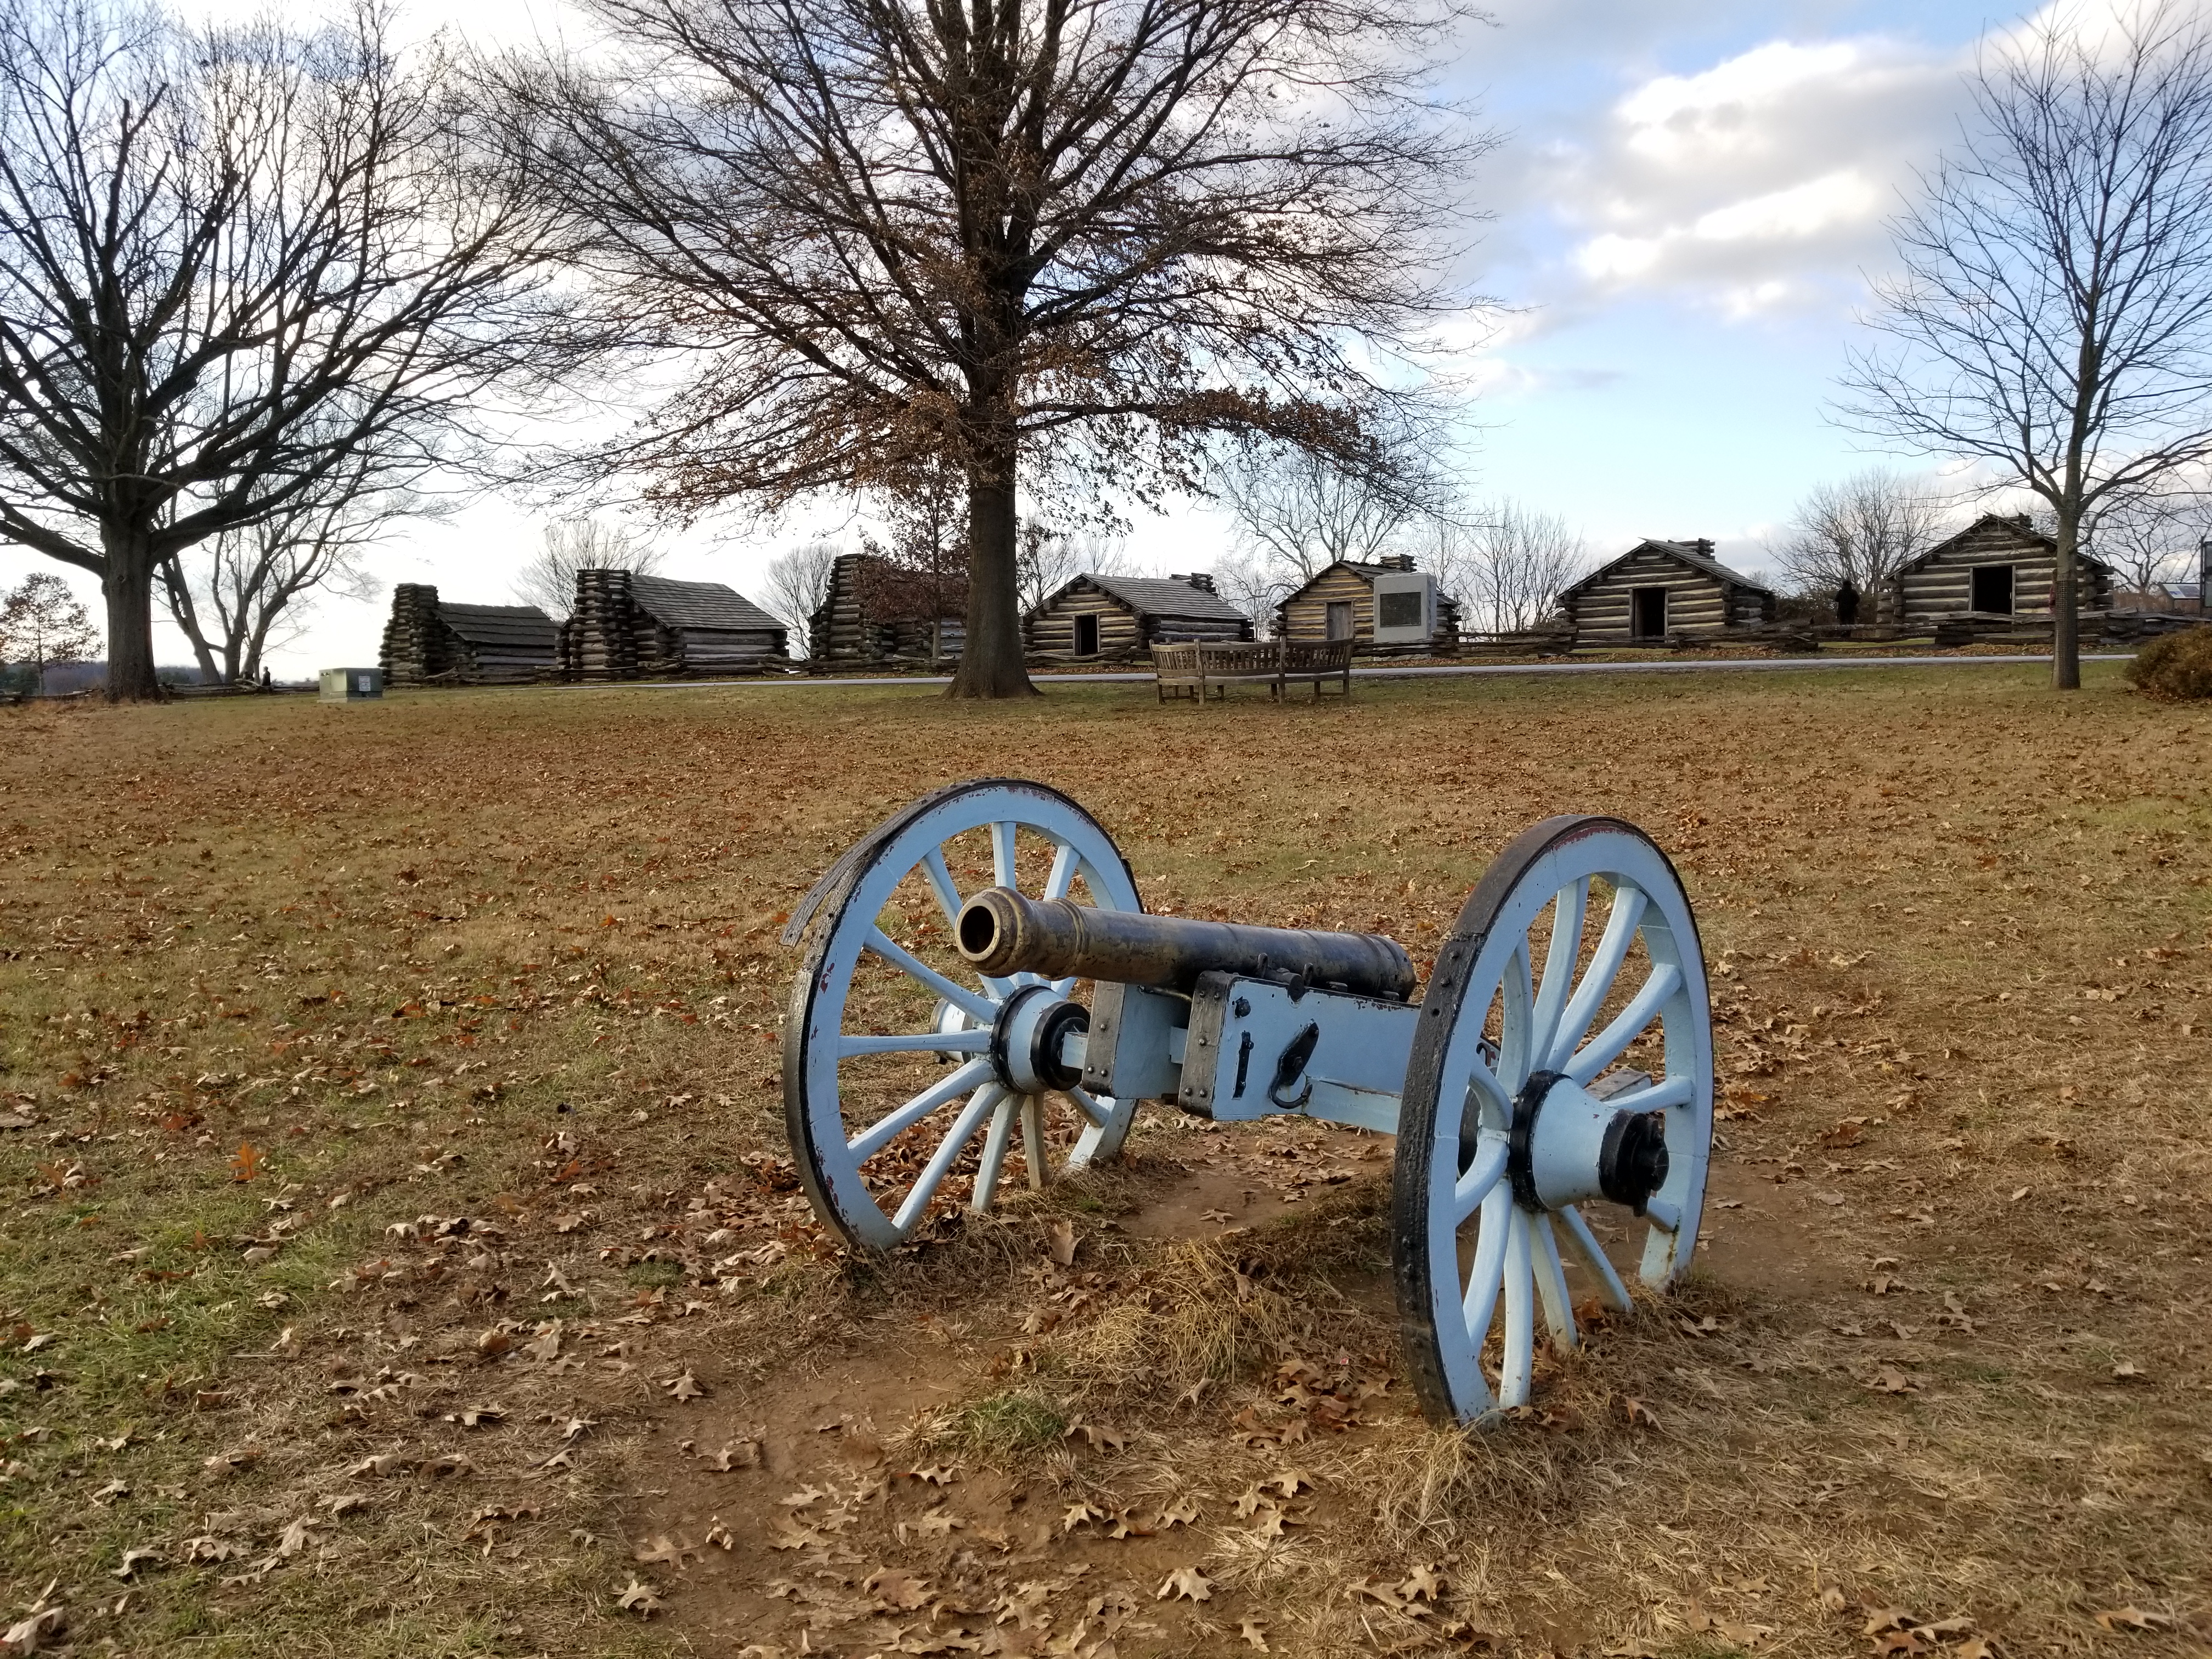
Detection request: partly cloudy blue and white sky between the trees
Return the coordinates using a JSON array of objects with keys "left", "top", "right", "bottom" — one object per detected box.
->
[{"left": 0, "top": 0, "right": 2017, "bottom": 677}]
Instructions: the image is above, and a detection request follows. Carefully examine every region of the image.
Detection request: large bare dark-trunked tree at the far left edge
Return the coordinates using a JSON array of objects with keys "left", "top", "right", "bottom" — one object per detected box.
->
[{"left": 0, "top": 0, "right": 562, "bottom": 697}]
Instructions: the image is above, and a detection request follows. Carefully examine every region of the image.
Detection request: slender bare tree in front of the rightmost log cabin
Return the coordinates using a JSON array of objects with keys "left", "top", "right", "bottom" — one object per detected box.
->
[{"left": 1845, "top": 4, "right": 2212, "bottom": 690}]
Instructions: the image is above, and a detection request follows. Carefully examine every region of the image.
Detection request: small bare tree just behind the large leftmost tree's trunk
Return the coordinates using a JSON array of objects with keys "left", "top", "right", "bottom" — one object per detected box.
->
[{"left": 161, "top": 500, "right": 392, "bottom": 686}]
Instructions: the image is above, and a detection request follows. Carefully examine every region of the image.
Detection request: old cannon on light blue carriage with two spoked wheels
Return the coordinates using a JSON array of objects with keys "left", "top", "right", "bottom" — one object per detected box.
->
[{"left": 783, "top": 778, "right": 1712, "bottom": 1423}]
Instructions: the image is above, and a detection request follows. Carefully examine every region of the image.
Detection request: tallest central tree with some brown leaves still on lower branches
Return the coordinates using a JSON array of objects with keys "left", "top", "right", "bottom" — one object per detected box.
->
[{"left": 482, "top": 0, "right": 1489, "bottom": 697}]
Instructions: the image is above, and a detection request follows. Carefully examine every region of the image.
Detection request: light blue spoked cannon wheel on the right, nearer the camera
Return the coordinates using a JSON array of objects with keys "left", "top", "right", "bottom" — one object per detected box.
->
[{"left": 1391, "top": 816, "right": 1712, "bottom": 1423}]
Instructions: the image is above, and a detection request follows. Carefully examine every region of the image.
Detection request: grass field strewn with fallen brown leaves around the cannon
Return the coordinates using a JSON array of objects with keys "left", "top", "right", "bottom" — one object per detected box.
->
[{"left": 0, "top": 668, "right": 2212, "bottom": 1659}]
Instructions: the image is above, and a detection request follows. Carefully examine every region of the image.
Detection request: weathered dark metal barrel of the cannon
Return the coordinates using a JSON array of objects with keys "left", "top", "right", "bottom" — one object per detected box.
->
[{"left": 958, "top": 887, "right": 1413, "bottom": 1000}]
